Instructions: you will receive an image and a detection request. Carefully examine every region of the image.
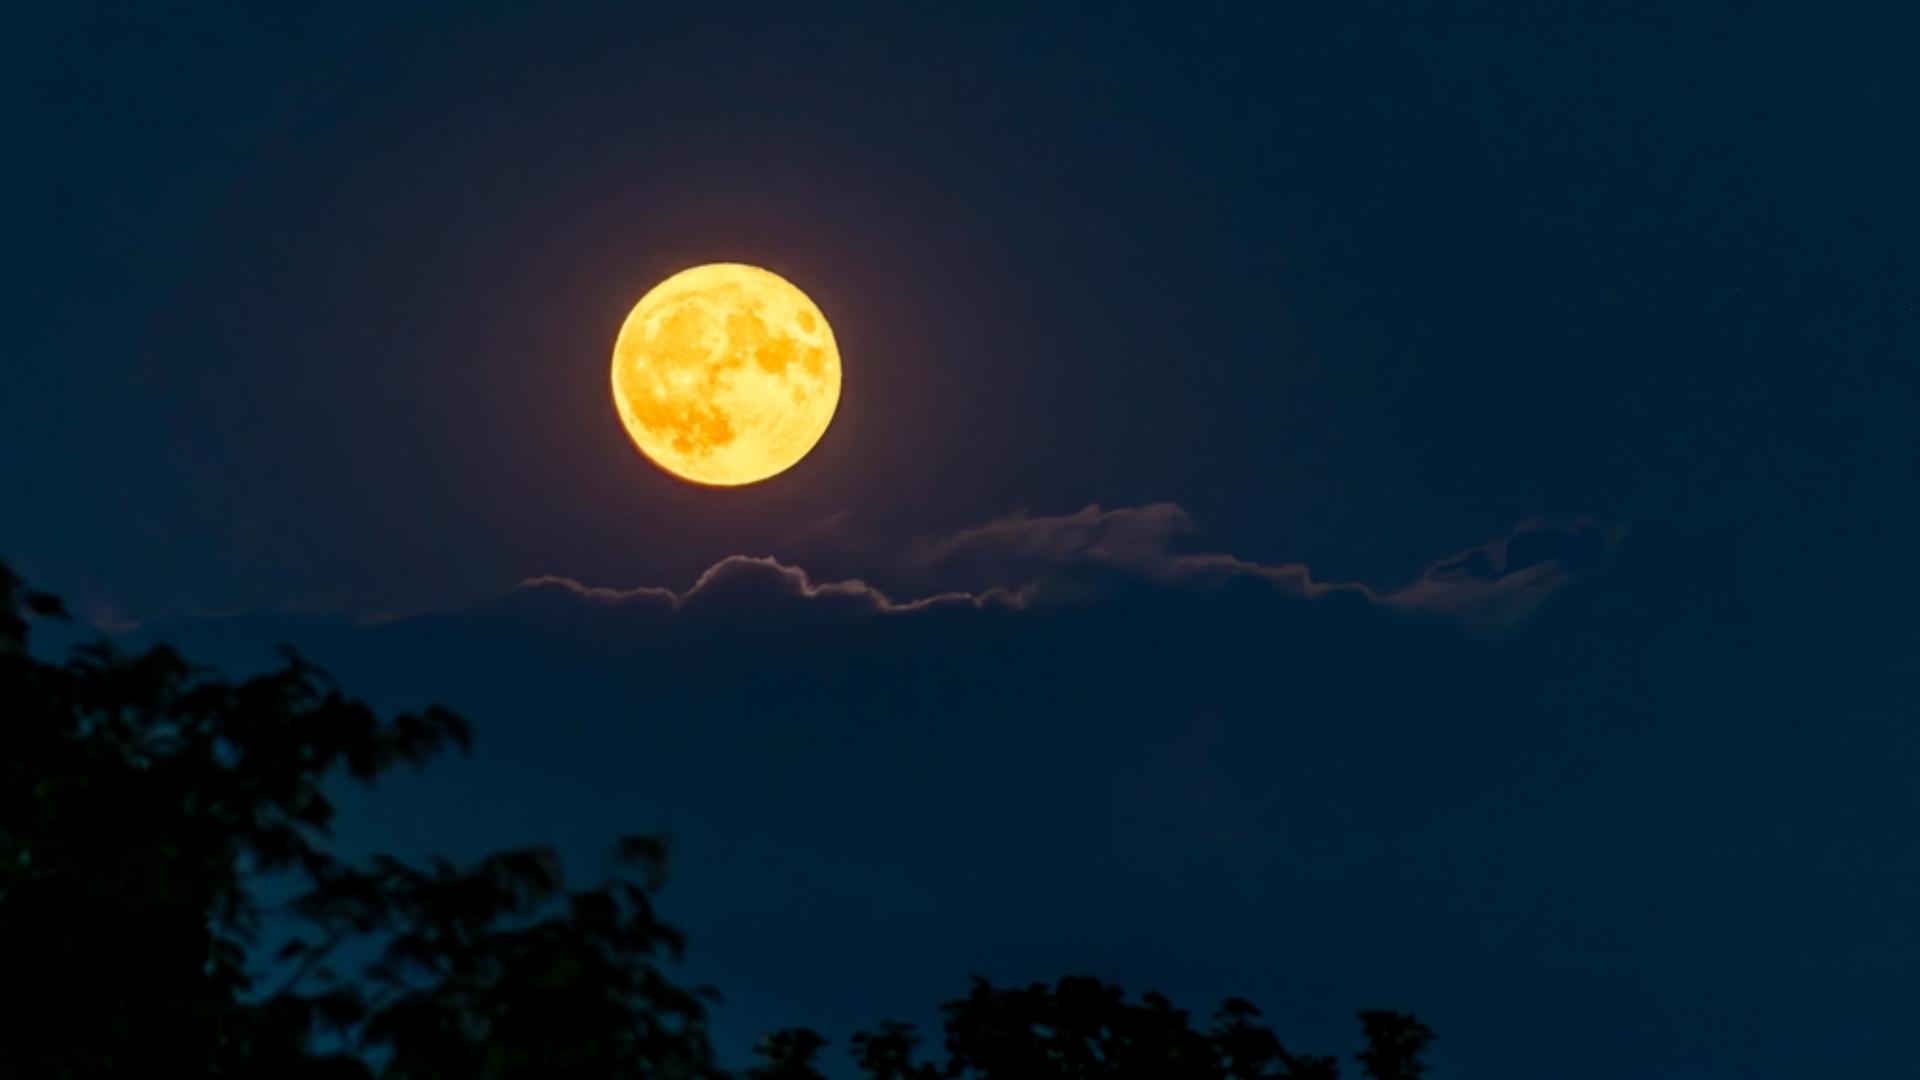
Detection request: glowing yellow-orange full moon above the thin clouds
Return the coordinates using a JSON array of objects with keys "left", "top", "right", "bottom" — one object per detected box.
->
[{"left": 612, "top": 263, "right": 839, "bottom": 488}]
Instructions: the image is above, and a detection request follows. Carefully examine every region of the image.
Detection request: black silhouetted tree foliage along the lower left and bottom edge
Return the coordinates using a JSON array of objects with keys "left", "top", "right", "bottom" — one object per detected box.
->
[{"left": 0, "top": 565, "right": 1432, "bottom": 1080}]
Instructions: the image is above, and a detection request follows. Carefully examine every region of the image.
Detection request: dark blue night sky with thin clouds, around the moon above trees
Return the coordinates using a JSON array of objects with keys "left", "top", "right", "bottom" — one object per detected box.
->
[{"left": 0, "top": 2, "right": 1920, "bottom": 1080}]
